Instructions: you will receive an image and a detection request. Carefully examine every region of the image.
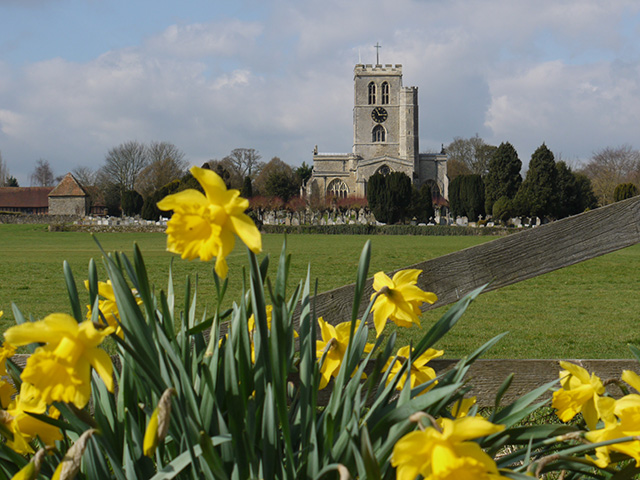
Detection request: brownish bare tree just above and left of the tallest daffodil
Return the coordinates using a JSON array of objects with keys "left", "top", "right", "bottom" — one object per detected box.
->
[{"left": 135, "top": 142, "right": 187, "bottom": 198}]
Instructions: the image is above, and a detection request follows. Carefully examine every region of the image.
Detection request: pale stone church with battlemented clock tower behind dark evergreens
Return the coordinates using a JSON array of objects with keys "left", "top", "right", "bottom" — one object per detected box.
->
[{"left": 307, "top": 64, "right": 449, "bottom": 199}]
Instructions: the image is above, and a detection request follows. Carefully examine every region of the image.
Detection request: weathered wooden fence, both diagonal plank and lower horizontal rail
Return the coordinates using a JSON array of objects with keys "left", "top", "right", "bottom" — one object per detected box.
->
[{"left": 304, "top": 196, "right": 640, "bottom": 406}]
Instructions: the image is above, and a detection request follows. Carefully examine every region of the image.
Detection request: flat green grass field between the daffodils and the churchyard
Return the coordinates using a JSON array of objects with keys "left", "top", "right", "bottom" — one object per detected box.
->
[{"left": 0, "top": 225, "right": 640, "bottom": 358}]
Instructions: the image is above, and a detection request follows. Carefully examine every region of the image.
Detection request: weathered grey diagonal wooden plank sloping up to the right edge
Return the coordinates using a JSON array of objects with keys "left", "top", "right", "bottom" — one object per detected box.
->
[{"left": 315, "top": 196, "right": 640, "bottom": 324}]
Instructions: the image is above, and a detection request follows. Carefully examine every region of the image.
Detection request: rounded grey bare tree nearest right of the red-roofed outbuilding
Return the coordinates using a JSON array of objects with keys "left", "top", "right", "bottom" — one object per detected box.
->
[{"left": 98, "top": 141, "right": 149, "bottom": 193}]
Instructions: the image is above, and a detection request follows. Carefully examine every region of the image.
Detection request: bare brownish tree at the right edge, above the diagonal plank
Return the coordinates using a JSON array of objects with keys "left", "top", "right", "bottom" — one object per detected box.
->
[{"left": 581, "top": 145, "right": 640, "bottom": 205}]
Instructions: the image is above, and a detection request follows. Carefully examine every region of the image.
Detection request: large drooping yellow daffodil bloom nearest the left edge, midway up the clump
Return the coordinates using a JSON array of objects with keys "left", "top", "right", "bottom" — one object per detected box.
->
[{"left": 4, "top": 313, "right": 115, "bottom": 408}]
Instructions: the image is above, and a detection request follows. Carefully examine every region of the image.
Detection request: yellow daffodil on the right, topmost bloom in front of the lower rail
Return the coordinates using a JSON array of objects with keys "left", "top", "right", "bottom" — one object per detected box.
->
[{"left": 551, "top": 362, "right": 615, "bottom": 430}]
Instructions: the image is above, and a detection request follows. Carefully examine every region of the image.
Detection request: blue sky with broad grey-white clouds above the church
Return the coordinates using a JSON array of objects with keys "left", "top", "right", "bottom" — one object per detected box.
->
[{"left": 0, "top": 0, "right": 640, "bottom": 186}]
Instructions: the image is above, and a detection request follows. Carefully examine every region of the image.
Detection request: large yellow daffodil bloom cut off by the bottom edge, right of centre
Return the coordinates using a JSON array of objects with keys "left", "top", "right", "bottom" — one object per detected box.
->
[{"left": 391, "top": 417, "right": 506, "bottom": 480}]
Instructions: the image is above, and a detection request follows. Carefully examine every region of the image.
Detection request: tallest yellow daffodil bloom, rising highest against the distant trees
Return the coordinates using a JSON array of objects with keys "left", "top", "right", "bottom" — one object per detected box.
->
[{"left": 158, "top": 167, "right": 262, "bottom": 278}]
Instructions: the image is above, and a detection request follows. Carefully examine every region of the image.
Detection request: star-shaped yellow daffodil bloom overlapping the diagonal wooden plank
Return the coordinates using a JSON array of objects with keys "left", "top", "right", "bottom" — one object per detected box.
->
[{"left": 371, "top": 269, "right": 438, "bottom": 336}]
